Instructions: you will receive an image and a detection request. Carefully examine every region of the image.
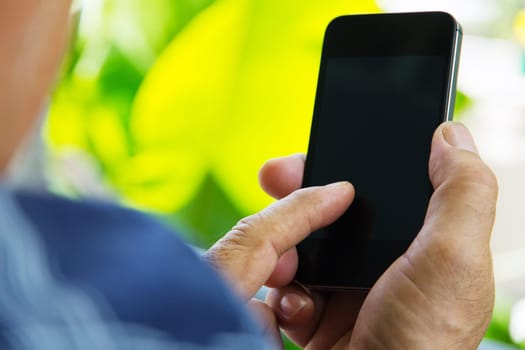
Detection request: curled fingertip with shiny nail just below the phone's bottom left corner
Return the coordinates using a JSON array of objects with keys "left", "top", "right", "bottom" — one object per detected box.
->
[{"left": 266, "top": 284, "right": 324, "bottom": 347}]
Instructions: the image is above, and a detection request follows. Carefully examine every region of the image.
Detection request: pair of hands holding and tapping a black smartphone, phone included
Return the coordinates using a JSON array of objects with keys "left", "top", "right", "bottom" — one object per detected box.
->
[{"left": 207, "top": 12, "right": 497, "bottom": 349}]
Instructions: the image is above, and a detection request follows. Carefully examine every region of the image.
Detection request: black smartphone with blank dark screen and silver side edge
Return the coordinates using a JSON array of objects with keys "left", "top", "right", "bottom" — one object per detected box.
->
[{"left": 296, "top": 12, "right": 462, "bottom": 289}]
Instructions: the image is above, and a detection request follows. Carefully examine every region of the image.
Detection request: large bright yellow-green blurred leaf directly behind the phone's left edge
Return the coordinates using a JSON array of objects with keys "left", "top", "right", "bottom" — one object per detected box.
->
[{"left": 131, "top": 0, "right": 378, "bottom": 212}]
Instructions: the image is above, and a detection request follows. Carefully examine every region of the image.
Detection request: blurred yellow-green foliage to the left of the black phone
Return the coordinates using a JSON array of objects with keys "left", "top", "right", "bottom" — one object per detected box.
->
[{"left": 46, "top": 0, "right": 378, "bottom": 246}]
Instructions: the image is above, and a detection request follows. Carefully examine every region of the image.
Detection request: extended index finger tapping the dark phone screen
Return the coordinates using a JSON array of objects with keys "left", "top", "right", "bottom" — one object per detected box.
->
[{"left": 205, "top": 182, "right": 354, "bottom": 298}]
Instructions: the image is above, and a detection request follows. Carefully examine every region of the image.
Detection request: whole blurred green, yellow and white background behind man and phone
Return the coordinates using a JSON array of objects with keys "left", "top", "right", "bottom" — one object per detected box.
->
[{"left": 10, "top": 0, "right": 525, "bottom": 348}]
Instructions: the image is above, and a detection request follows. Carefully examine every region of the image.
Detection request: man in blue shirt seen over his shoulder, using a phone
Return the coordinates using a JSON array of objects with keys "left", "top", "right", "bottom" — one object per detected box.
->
[{"left": 0, "top": 0, "right": 497, "bottom": 349}]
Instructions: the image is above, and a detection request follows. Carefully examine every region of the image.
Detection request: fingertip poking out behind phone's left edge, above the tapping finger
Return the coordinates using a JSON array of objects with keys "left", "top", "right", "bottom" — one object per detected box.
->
[{"left": 259, "top": 154, "right": 305, "bottom": 199}]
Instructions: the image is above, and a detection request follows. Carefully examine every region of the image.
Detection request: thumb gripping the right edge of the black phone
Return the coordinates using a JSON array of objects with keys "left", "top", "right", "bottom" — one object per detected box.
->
[{"left": 421, "top": 122, "right": 498, "bottom": 248}]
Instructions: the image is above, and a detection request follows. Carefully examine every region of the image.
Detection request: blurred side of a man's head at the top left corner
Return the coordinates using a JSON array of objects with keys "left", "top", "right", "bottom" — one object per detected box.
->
[{"left": 0, "top": 0, "right": 71, "bottom": 172}]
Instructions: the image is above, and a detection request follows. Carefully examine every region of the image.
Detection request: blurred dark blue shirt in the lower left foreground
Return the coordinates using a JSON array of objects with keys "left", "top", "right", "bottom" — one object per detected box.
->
[{"left": 0, "top": 191, "right": 268, "bottom": 349}]
